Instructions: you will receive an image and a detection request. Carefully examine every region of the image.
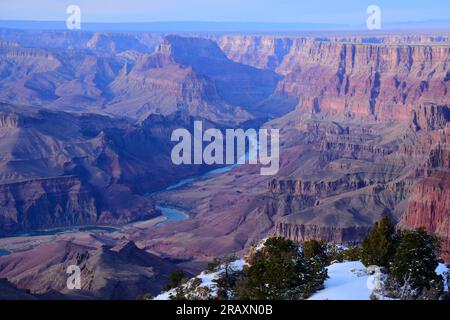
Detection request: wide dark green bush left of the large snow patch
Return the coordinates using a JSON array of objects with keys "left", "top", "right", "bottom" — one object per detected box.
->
[{"left": 237, "top": 238, "right": 327, "bottom": 300}]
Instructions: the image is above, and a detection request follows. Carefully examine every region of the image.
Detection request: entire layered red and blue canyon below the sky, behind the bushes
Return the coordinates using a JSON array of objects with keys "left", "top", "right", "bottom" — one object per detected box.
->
[{"left": 0, "top": 29, "right": 450, "bottom": 299}]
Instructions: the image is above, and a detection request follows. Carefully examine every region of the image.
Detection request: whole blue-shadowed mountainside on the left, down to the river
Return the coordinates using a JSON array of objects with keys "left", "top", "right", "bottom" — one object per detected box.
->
[{"left": 0, "top": 105, "right": 216, "bottom": 234}]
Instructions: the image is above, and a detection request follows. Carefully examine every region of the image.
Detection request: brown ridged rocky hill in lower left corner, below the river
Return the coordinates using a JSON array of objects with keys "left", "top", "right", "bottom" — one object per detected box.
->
[{"left": 0, "top": 241, "right": 176, "bottom": 300}]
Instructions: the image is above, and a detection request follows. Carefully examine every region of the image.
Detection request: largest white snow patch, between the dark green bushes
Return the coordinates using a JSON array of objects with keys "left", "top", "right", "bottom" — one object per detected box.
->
[{"left": 309, "top": 261, "right": 372, "bottom": 300}]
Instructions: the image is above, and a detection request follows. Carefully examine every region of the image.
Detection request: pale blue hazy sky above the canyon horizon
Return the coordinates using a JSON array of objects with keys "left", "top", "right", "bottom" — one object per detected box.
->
[{"left": 0, "top": 0, "right": 450, "bottom": 25}]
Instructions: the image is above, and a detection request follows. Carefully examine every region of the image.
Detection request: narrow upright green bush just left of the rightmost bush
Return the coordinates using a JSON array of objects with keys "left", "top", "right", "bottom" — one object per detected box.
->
[{"left": 361, "top": 216, "right": 397, "bottom": 268}]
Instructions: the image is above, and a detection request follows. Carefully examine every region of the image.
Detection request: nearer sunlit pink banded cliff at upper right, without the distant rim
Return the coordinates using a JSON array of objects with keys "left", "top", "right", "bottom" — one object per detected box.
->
[{"left": 278, "top": 42, "right": 450, "bottom": 120}]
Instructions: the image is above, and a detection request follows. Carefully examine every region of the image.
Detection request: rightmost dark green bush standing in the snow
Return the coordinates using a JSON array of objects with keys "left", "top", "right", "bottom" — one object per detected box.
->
[{"left": 390, "top": 228, "right": 442, "bottom": 289}]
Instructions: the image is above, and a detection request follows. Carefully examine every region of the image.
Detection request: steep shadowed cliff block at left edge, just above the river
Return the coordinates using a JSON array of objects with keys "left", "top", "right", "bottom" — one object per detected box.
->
[{"left": 0, "top": 177, "right": 99, "bottom": 234}]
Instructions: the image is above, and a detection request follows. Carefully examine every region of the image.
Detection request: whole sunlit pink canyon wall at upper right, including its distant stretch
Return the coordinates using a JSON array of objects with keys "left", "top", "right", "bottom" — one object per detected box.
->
[{"left": 218, "top": 36, "right": 450, "bottom": 120}]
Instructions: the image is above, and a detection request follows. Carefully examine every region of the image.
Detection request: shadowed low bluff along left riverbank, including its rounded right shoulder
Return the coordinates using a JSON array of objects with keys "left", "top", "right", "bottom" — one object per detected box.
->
[{"left": 0, "top": 176, "right": 158, "bottom": 235}]
